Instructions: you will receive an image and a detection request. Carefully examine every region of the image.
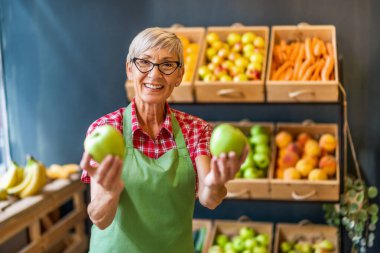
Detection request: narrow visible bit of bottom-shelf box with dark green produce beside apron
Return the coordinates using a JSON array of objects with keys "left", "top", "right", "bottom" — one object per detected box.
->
[{"left": 193, "top": 219, "right": 212, "bottom": 253}]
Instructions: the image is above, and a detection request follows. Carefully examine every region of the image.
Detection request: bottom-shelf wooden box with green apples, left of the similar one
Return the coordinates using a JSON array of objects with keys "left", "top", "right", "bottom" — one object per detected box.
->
[{"left": 207, "top": 220, "right": 273, "bottom": 252}]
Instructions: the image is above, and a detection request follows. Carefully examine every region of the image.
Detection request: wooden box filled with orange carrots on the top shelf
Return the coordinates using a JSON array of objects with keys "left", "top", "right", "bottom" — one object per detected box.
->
[{"left": 266, "top": 24, "right": 339, "bottom": 102}]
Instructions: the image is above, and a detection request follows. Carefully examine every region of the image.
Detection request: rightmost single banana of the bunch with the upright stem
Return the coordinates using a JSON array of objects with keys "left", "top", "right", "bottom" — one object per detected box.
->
[{"left": 20, "top": 157, "right": 46, "bottom": 198}]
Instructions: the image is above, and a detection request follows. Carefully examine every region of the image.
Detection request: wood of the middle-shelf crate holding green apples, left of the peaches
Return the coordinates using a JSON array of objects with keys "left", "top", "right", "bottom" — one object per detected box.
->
[{"left": 212, "top": 121, "right": 276, "bottom": 199}]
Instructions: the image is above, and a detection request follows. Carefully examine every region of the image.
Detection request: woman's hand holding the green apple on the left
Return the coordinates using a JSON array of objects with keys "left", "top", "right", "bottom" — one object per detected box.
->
[{"left": 80, "top": 152, "right": 124, "bottom": 194}]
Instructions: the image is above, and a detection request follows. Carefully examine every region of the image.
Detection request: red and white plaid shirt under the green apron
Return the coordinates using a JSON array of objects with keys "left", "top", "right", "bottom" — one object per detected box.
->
[{"left": 81, "top": 100, "right": 212, "bottom": 192}]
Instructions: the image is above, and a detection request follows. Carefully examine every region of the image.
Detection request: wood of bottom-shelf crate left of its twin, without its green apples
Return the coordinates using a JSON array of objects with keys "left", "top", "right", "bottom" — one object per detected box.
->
[{"left": 207, "top": 220, "right": 273, "bottom": 252}]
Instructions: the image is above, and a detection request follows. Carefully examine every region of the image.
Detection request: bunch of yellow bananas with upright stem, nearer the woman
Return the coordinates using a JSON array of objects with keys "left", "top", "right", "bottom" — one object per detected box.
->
[{"left": 7, "top": 156, "right": 46, "bottom": 198}]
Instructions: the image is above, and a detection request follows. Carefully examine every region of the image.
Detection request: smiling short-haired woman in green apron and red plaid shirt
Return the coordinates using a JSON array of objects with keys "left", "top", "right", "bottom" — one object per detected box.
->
[{"left": 81, "top": 28, "right": 247, "bottom": 253}]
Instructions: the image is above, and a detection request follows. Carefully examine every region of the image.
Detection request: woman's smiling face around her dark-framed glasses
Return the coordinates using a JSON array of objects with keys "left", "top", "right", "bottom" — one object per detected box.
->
[{"left": 126, "top": 48, "right": 184, "bottom": 104}]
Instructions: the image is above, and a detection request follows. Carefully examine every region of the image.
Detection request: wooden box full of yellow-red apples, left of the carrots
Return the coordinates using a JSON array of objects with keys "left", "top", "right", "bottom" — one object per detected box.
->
[{"left": 195, "top": 26, "right": 269, "bottom": 103}]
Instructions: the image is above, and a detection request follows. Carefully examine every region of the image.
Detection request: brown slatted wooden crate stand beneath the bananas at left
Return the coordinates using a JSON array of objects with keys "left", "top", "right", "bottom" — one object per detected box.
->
[{"left": 0, "top": 175, "right": 88, "bottom": 253}]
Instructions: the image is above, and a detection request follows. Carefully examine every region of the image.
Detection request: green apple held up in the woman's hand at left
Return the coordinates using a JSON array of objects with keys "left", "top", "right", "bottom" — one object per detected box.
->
[{"left": 84, "top": 125, "right": 125, "bottom": 163}]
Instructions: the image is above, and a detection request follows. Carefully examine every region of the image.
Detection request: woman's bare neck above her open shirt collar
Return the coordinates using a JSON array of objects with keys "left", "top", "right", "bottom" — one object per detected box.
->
[{"left": 135, "top": 100, "right": 166, "bottom": 139}]
